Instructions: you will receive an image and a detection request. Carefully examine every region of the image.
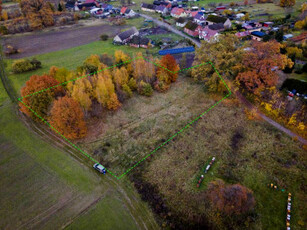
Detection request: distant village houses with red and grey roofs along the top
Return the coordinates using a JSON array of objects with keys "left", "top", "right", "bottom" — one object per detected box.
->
[{"left": 66, "top": 0, "right": 307, "bottom": 48}]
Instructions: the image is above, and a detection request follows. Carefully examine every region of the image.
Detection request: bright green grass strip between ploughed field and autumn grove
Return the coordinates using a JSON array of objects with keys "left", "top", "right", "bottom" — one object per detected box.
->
[{"left": 6, "top": 39, "right": 158, "bottom": 96}]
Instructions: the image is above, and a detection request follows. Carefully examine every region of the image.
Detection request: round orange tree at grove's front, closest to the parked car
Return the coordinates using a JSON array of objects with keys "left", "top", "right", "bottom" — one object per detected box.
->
[{"left": 49, "top": 96, "right": 87, "bottom": 139}]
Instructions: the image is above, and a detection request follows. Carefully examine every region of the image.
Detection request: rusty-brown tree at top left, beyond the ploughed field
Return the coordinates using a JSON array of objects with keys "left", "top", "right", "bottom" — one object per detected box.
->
[{"left": 20, "top": 0, "right": 54, "bottom": 30}]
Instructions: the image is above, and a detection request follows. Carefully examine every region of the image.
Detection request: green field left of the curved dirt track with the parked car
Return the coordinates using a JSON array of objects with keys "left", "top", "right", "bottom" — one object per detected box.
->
[{"left": 0, "top": 78, "right": 158, "bottom": 229}]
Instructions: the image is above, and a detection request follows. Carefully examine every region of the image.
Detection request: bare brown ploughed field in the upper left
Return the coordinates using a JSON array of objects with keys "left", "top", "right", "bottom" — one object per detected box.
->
[{"left": 3, "top": 24, "right": 125, "bottom": 59}]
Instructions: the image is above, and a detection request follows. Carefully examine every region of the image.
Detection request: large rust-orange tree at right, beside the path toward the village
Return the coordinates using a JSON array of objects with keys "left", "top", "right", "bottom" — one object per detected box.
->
[{"left": 236, "top": 41, "right": 294, "bottom": 94}]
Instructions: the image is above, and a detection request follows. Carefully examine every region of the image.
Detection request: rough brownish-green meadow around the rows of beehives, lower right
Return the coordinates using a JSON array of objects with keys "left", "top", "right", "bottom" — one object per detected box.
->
[{"left": 139, "top": 96, "right": 307, "bottom": 229}]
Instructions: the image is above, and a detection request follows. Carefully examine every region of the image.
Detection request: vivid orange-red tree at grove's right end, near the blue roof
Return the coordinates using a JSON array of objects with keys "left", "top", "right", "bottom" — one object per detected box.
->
[{"left": 157, "top": 54, "right": 180, "bottom": 84}]
